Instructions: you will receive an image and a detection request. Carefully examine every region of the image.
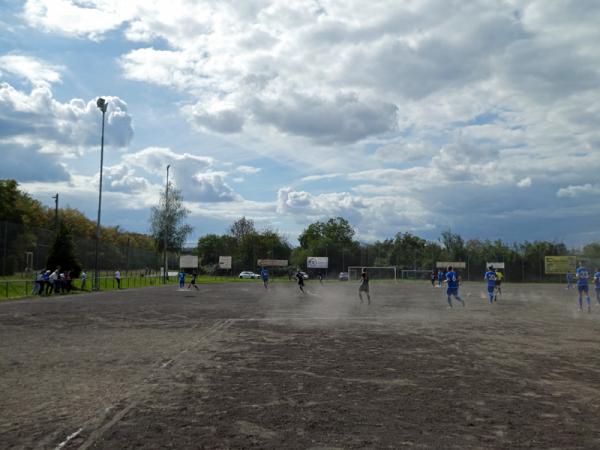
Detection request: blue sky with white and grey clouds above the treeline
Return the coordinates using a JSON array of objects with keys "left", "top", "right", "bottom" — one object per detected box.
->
[{"left": 0, "top": 0, "right": 600, "bottom": 247}]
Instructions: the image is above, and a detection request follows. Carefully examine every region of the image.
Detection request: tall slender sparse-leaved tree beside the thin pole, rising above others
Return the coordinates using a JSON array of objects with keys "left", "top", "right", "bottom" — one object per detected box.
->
[{"left": 150, "top": 182, "right": 193, "bottom": 252}]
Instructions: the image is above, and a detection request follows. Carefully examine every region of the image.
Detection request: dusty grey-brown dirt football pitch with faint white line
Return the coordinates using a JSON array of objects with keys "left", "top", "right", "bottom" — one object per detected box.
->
[{"left": 0, "top": 282, "right": 600, "bottom": 449}]
